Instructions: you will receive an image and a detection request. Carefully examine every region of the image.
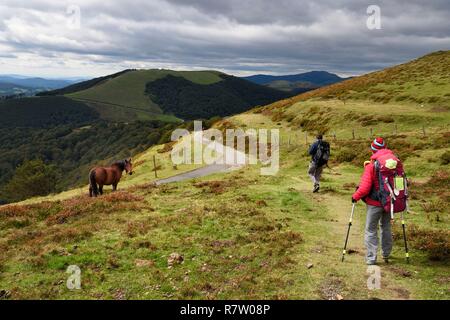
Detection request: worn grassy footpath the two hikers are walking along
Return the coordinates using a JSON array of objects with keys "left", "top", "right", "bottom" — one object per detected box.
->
[{"left": 292, "top": 173, "right": 410, "bottom": 299}]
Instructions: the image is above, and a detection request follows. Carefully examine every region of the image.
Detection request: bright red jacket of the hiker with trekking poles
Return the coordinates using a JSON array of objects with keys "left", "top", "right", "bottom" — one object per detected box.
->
[{"left": 352, "top": 149, "right": 393, "bottom": 207}]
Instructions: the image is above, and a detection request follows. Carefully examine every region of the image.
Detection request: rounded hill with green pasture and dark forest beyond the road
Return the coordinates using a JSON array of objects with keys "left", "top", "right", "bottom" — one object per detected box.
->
[{"left": 38, "top": 69, "right": 291, "bottom": 121}]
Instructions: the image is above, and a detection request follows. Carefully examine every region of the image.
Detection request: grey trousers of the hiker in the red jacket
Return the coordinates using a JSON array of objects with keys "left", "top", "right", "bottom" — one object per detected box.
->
[{"left": 364, "top": 205, "right": 392, "bottom": 262}]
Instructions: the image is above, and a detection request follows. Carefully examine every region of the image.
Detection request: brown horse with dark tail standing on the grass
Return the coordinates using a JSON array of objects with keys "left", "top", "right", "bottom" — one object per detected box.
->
[{"left": 89, "top": 158, "right": 133, "bottom": 197}]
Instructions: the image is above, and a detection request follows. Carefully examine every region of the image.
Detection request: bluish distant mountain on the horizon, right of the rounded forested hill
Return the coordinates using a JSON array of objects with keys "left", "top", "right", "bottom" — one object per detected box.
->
[{"left": 243, "top": 71, "right": 345, "bottom": 94}]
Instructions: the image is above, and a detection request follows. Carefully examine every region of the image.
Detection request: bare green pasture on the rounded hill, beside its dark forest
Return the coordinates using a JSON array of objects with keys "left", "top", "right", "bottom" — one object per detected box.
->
[{"left": 67, "top": 69, "right": 221, "bottom": 120}]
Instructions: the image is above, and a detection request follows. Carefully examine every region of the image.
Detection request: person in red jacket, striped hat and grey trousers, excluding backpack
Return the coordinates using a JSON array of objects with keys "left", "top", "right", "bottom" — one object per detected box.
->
[{"left": 352, "top": 138, "right": 393, "bottom": 265}]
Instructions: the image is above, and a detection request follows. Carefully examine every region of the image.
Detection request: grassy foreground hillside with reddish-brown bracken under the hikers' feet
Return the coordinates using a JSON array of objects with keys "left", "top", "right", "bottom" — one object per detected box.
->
[{"left": 0, "top": 51, "right": 450, "bottom": 299}]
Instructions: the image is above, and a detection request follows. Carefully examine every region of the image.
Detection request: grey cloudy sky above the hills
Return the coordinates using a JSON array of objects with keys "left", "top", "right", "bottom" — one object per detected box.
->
[{"left": 0, "top": 0, "right": 450, "bottom": 77}]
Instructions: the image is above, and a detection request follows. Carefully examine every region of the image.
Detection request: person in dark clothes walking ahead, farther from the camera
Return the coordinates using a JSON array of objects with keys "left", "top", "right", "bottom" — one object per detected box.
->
[{"left": 308, "top": 134, "right": 330, "bottom": 192}]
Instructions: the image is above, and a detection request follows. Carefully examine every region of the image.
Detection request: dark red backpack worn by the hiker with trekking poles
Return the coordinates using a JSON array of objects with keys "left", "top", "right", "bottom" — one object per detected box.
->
[{"left": 373, "top": 153, "right": 407, "bottom": 218}]
